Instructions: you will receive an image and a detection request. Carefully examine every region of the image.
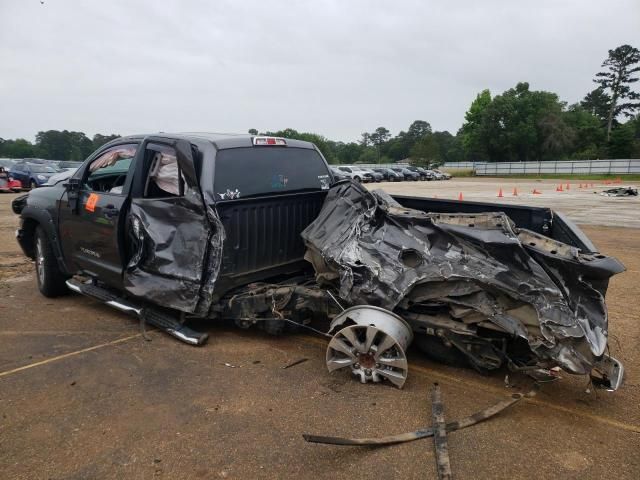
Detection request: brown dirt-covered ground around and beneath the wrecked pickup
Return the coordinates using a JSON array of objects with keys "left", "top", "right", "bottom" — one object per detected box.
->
[{"left": 0, "top": 180, "right": 640, "bottom": 479}]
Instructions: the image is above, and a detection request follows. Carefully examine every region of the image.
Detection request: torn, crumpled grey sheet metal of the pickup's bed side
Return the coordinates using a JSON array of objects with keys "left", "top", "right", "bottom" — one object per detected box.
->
[{"left": 302, "top": 182, "right": 624, "bottom": 374}]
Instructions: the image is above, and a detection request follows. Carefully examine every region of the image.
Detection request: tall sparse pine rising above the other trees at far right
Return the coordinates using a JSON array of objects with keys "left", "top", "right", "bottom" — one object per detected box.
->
[{"left": 593, "top": 45, "right": 640, "bottom": 141}]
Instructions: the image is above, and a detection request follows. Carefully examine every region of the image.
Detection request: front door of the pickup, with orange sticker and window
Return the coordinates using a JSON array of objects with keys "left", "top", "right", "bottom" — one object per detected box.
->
[{"left": 58, "top": 144, "right": 137, "bottom": 287}]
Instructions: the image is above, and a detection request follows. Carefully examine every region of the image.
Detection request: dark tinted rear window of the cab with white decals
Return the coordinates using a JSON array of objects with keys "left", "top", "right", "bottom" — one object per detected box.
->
[{"left": 214, "top": 146, "right": 331, "bottom": 201}]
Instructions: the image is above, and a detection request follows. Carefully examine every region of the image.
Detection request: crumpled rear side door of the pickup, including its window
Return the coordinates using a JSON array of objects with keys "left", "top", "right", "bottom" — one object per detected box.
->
[{"left": 124, "top": 137, "right": 211, "bottom": 312}]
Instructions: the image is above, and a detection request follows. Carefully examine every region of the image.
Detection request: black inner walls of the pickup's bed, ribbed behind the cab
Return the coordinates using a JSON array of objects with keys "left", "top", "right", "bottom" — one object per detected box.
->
[{"left": 216, "top": 191, "right": 596, "bottom": 296}]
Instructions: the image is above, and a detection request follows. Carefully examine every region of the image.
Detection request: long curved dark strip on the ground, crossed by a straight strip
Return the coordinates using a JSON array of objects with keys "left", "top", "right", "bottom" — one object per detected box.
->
[{"left": 302, "top": 384, "right": 539, "bottom": 446}]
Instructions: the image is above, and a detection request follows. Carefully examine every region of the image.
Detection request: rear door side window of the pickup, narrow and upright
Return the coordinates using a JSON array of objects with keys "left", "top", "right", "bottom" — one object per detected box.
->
[{"left": 143, "top": 144, "right": 184, "bottom": 198}]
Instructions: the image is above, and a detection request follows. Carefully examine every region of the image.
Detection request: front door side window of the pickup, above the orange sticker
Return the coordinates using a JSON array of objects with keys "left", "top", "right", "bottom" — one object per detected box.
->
[{"left": 84, "top": 145, "right": 137, "bottom": 195}]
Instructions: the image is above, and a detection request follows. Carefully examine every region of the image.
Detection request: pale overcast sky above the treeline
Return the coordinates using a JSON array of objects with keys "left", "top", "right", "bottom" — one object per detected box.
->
[{"left": 0, "top": 0, "right": 640, "bottom": 141}]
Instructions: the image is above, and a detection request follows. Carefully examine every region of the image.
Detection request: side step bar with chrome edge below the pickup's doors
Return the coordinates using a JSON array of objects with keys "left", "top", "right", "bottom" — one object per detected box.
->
[{"left": 66, "top": 278, "right": 209, "bottom": 345}]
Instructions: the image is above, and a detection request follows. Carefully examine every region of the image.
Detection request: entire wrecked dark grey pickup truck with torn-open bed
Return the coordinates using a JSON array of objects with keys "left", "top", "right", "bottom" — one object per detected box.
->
[{"left": 12, "top": 134, "right": 624, "bottom": 389}]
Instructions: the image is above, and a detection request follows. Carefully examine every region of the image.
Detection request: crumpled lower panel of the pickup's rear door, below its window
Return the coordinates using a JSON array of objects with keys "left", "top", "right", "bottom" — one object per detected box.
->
[{"left": 124, "top": 190, "right": 224, "bottom": 315}]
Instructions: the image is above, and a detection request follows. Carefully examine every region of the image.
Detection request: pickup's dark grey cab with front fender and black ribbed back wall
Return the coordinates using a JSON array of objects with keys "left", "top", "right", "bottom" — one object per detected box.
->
[{"left": 17, "top": 134, "right": 332, "bottom": 313}]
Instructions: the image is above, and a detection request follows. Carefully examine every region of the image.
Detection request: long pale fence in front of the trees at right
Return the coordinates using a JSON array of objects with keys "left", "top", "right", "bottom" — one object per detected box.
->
[{"left": 474, "top": 159, "right": 640, "bottom": 175}]
